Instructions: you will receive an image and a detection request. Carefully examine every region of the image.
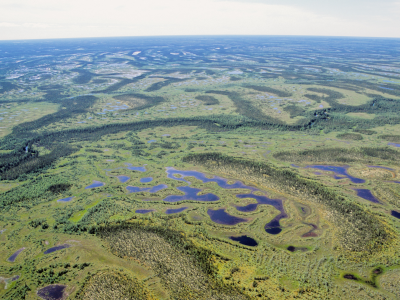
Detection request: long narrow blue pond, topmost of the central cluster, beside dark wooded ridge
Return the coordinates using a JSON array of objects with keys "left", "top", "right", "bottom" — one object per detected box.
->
[{"left": 167, "top": 167, "right": 257, "bottom": 191}]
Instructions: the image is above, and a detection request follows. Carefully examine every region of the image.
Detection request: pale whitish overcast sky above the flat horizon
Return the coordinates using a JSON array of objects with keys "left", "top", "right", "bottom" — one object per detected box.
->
[{"left": 0, "top": 0, "right": 400, "bottom": 40}]
